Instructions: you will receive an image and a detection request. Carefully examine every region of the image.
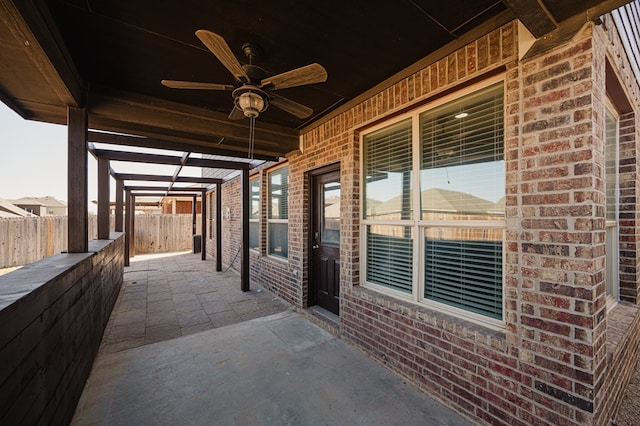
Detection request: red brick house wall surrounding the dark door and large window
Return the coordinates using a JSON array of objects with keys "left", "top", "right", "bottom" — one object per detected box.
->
[{"left": 209, "top": 17, "right": 640, "bottom": 425}]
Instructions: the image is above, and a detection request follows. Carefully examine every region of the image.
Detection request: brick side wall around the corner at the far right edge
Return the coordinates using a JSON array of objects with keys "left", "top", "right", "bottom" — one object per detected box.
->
[{"left": 594, "top": 17, "right": 640, "bottom": 424}]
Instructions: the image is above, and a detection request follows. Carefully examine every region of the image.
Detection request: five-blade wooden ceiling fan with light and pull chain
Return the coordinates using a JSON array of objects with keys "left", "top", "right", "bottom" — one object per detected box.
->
[{"left": 162, "top": 30, "right": 327, "bottom": 120}]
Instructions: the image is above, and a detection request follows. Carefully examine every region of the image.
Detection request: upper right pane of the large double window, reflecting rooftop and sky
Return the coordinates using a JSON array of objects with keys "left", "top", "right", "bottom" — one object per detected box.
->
[{"left": 420, "top": 85, "right": 505, "bottom": 220}]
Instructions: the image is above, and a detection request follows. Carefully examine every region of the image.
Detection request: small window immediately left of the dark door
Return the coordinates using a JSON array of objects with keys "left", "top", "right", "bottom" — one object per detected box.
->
[{"left": 267, "top": 166, "right": 289, "bottom": 258}]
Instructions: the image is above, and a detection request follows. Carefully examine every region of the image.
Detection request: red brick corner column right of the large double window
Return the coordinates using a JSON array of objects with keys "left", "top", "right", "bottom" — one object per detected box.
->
[{"left": 506, "top": 26, "right": 605, "bottom": 424}]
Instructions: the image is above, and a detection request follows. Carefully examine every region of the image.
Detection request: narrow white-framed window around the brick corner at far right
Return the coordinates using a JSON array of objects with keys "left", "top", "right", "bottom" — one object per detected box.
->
[{"left": 604, "top": 99, "right": 620, "bottom": 310}]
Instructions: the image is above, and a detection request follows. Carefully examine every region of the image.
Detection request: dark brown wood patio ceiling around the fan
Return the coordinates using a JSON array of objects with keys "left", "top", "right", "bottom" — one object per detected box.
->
[{"left": 0, "top": 0, "right": 627, "bottom": 160}]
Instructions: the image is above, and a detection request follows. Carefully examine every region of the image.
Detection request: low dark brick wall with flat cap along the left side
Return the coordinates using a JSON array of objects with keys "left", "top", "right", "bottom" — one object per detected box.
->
[{"left": 0, "top": 234, "right": 124, "bottom": 424}]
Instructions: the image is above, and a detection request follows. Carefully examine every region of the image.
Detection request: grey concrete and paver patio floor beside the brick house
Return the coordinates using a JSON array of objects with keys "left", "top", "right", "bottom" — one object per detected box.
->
[{"left": 72, "top": 253, "right": 471, "bottom": 425}]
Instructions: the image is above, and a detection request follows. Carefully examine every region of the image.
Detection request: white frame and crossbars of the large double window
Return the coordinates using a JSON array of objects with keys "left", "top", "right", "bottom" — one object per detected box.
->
[{"left": 360, "top": 74, "right": 506, "bottom": 330}]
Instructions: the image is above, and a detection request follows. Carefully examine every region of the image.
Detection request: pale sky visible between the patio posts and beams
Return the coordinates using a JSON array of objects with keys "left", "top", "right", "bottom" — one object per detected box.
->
[{"left": 0, "top": 102, "right": 201, "bottom": 213}]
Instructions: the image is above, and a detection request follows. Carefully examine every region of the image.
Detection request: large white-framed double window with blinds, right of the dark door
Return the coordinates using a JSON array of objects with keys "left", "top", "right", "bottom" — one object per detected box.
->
[{"left": 362, "top": 81, "right": 505, "bottom": 321}]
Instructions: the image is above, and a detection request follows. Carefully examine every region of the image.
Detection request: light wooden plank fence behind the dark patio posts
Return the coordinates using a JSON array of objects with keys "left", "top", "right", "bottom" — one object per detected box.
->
[{"left": 0, "top": 214, "right": 201, "bottom": 268}]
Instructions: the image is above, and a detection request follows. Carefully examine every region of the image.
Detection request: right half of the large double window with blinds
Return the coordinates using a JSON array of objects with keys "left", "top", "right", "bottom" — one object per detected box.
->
[{"left": 420, "top": 83, "right": 505, "bottom": 319}]
